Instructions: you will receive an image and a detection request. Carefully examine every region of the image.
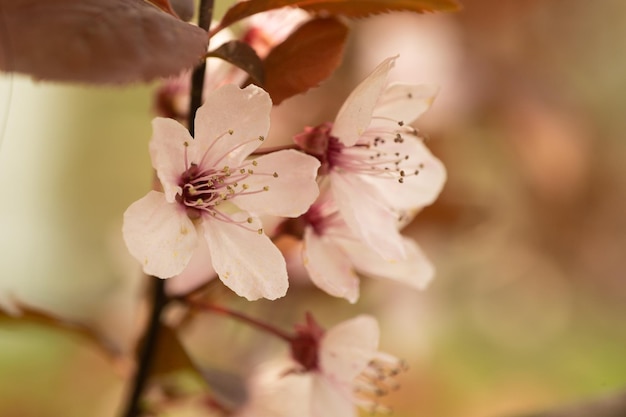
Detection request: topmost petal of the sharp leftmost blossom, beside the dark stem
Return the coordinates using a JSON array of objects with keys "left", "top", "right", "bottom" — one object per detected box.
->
[{"left": 189, "top": 84, "right": 272, "bottom": 169}]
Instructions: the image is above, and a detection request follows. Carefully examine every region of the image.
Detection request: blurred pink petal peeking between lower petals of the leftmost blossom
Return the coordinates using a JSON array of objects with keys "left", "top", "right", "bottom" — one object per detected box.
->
[{"left": 166, "top": 239, "right": 217, "bottom": 296}]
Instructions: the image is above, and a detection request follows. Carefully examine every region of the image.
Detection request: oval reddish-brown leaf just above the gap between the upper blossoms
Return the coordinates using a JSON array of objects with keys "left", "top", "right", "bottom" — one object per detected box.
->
[{"left": 263, "top": 18, "right": 348, "bottom": 104}]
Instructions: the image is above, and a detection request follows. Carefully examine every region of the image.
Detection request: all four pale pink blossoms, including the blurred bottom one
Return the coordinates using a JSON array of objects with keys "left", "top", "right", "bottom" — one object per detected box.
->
[{"left": 123, "top": 8, "right": 446, "bottom": 417}]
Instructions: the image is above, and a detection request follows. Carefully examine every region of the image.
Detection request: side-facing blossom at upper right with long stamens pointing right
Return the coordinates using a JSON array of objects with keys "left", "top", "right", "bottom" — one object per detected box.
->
[{"left": 294, "top": 58, "right": 446, "bottom": 260}]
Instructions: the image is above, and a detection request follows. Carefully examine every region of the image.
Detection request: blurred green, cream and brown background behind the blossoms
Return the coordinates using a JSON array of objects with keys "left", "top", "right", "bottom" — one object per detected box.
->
[{"left": 0, "top": 0, "right": 626, "bottom": 417}]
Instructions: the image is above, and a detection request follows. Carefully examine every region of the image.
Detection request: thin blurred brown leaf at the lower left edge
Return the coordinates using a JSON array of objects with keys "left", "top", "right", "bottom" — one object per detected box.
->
[{"left": 0, "top": 301, "right": 122, "bottom": 359}]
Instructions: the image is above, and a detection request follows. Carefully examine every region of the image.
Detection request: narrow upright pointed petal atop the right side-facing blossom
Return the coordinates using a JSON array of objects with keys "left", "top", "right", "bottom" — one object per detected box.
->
[{"left": 331, "top": 57, "right": 396, "bottom": 146}]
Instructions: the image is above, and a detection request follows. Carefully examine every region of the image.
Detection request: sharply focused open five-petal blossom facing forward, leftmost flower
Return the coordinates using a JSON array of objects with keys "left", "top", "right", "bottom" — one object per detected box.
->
[{"left": 123, "top": 85, "right": 319, "bottom": 300}]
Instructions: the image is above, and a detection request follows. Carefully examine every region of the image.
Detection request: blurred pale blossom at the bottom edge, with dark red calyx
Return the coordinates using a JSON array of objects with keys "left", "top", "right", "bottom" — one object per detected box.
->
[{"left": 244, "top": 315, "right": 404, "bottom": 417}]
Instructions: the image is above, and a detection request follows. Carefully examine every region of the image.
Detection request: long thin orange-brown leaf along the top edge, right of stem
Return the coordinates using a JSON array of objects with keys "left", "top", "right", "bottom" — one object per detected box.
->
[{"left": 214, "top": 0, "right": 460, "bottom": 32}]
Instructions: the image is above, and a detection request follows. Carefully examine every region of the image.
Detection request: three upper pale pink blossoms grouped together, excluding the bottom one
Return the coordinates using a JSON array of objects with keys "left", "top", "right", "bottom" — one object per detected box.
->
[{"left": 123, "top": 58, "right": 445, "bottom": 302}]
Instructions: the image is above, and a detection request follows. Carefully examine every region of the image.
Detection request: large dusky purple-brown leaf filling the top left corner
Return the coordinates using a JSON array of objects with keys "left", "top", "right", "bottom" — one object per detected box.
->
[{"left": 0, "top": 0, "right": 207, "bottom": 84}]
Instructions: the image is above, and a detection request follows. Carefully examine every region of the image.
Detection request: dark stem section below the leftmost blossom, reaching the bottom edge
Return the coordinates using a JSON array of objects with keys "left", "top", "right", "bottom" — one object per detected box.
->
[{"left": 123, "top": 277, "right": 169, "bottom": 417}]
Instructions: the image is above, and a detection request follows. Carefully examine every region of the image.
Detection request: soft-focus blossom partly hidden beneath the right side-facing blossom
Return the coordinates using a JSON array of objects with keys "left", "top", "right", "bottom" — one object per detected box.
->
[{"left": 303, "top": 193, "right": 434, "bottom": 303}]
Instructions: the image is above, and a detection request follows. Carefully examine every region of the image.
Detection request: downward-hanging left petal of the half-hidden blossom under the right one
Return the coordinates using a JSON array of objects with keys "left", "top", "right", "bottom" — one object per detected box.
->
[{"left": 302, "top": 227, "right": 358, "bottom": 303}]
